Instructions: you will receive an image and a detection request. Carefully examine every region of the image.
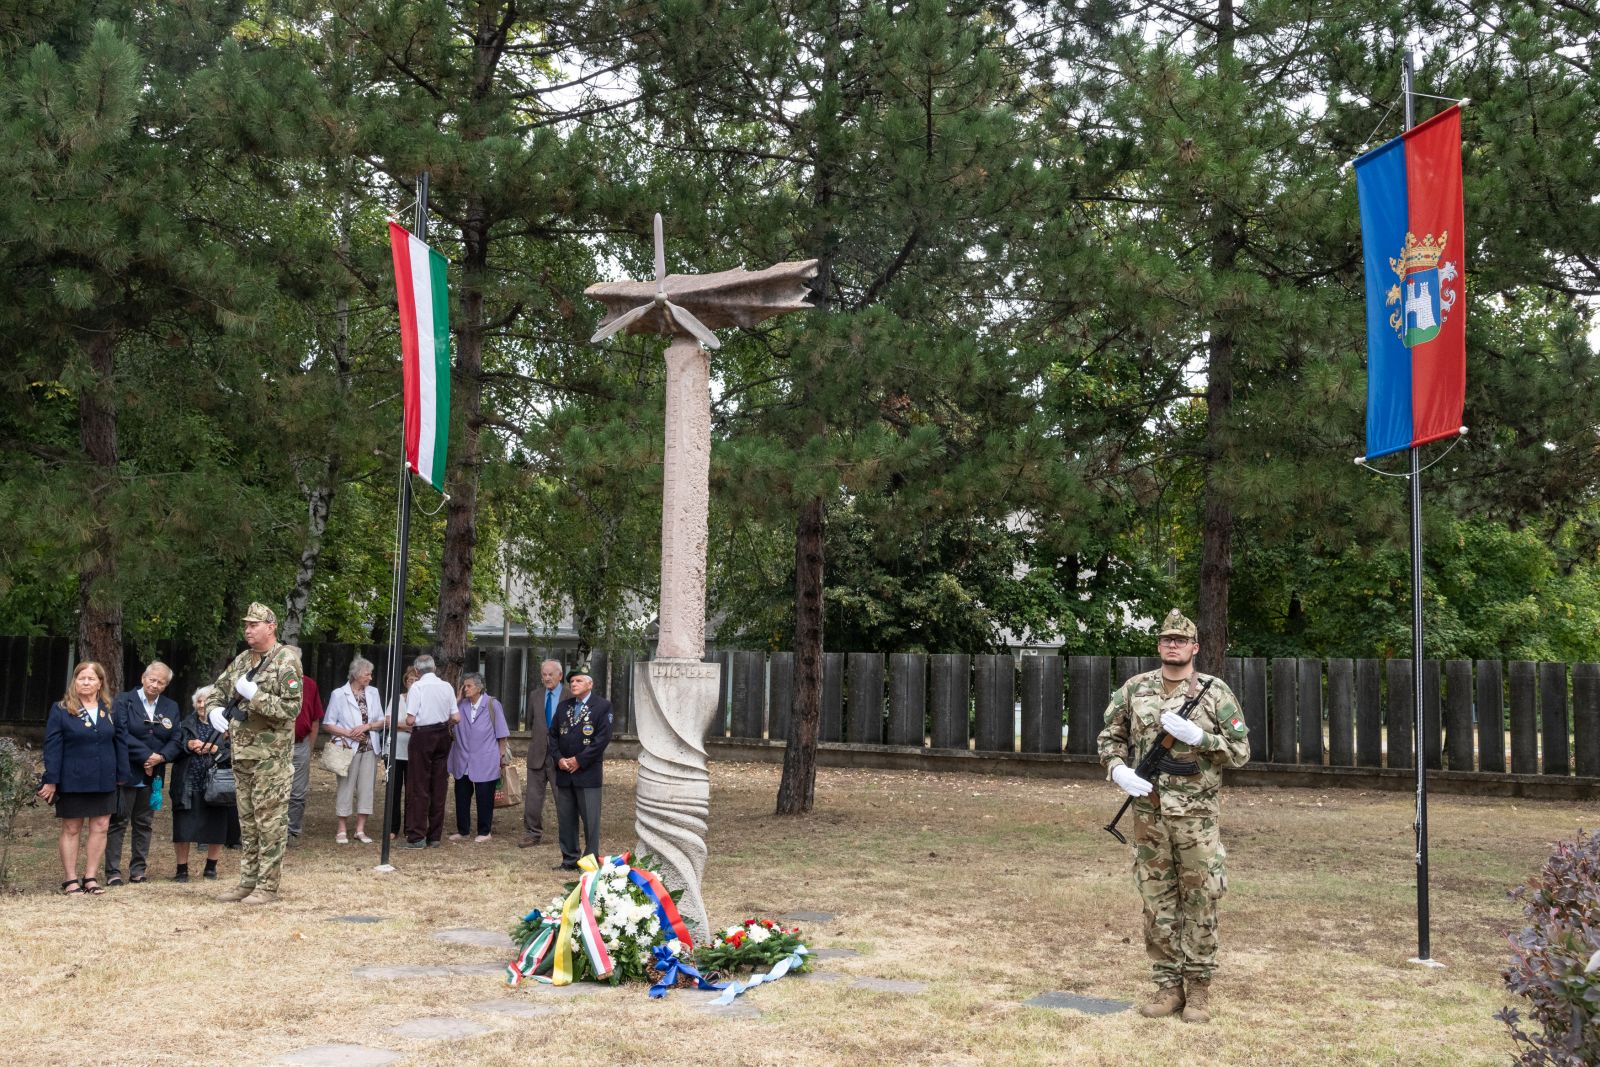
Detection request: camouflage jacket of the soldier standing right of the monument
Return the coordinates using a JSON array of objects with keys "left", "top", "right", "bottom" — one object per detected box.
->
[{"left": 1099, "top": 670, "right": 1250, "bottom": 816}]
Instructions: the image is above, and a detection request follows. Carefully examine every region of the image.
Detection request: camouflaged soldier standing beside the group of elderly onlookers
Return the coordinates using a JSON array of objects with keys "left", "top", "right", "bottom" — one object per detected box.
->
[{"left": 206, "top": 603, "right": 302, "bottom": 904}]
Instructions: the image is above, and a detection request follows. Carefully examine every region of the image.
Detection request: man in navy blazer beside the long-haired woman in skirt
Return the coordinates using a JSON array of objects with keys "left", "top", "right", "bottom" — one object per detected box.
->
[{"left": 106, "top": 659, "right": 182, "bottom": 886}]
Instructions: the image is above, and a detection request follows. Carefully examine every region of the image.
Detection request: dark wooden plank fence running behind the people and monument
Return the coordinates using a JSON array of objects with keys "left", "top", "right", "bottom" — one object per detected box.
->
[{"left": 0, "top": 638, "right": 1600, "bottom": 777}]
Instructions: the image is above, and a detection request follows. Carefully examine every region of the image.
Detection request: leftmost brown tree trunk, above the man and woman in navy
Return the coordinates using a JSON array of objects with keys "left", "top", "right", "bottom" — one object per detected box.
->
[{"left": 78, "top": 333, "right": 122, "bottom": 693}]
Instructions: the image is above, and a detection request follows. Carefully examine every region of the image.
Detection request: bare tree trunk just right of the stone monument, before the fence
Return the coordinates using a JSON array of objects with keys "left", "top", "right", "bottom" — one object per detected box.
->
[{"left": 778, "top": 498, "right": 826, "bottom": 816}]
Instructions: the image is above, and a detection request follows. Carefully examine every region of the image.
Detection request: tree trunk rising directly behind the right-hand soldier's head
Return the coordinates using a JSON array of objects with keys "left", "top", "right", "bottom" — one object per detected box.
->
[{"left": 1195, "top": 0, "right": 1238, "bottom": 675}]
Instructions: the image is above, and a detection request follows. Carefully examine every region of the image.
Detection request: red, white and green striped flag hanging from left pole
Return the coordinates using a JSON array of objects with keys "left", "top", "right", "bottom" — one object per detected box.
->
[{"left": 389, "top": 222, "right": 450, "bottom": 491}]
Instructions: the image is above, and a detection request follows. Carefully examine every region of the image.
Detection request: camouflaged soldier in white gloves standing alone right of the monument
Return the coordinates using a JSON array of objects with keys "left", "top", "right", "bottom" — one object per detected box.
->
[{"left": 1099, "top": 609, "right": 1250, "bottom": 1022}]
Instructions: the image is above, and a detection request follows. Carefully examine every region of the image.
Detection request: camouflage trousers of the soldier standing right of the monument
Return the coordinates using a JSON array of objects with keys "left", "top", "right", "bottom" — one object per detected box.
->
[{"left": 1133, "top": 805, "right": 1227, "bottom": 985}]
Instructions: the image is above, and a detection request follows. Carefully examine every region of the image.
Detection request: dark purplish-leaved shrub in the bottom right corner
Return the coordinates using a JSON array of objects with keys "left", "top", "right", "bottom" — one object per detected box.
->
[{"left": 1494, "top": 833, "right": 1600, "bottom": 1067}]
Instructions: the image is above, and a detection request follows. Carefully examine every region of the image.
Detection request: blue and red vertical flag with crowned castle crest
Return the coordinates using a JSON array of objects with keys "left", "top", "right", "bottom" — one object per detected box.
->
[{"left": 1355, "top": 106, "right": 1467, "bottom": 459}]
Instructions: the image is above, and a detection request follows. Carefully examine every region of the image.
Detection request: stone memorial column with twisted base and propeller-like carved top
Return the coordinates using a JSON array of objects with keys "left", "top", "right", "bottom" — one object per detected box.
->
[{"left": 586, "top": 214, "right": 816, "bottom": 941}]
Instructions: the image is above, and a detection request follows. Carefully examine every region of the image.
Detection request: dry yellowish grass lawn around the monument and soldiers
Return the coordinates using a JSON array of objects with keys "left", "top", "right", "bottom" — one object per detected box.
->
[{"left": 0, "top": 761, "right": 1595, "bottom": 1067}]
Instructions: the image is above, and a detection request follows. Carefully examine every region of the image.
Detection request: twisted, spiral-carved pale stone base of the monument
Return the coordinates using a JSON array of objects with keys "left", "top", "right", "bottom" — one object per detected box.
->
[{"left": 634, "top": 659, "right": 722, "bottom": 944}]
